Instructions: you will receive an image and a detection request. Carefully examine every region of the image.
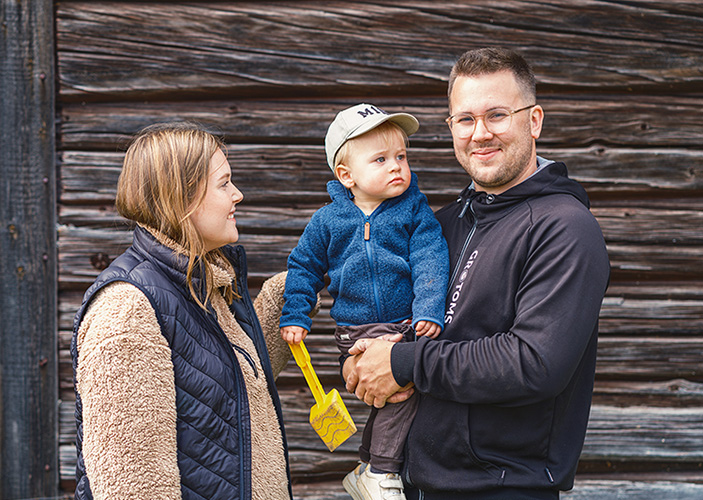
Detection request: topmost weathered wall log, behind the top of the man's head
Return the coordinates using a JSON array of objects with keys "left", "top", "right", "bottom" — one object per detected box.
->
[{"left": 56, "top": 0, "right": 703, "bottom": 100}]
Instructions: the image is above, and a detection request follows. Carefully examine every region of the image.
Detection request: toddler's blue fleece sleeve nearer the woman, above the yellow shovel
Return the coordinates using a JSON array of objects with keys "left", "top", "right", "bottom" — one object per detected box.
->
[{"left": 280, "top": 210, "right": 330, "bottom": 331}]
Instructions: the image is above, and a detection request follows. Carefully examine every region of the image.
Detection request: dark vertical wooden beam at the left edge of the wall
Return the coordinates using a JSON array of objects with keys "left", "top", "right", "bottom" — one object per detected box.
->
[{"left": 0, "top": 0, "right": 58, "bottom": 499}]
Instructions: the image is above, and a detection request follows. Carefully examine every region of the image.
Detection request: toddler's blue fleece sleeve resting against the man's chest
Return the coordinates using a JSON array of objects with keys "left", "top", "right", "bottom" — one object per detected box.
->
[{"left": 409, "top": 191, "right": 449, "bottom": 327}]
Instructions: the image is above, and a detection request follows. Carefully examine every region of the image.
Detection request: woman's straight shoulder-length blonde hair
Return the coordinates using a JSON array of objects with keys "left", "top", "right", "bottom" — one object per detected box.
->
[{"left": 115, "top": 122, "right": 234, "bottom": 309}]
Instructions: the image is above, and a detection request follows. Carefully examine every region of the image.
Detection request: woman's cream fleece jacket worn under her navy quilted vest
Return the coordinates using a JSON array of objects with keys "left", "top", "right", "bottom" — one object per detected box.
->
[{"left": 76, "top": 236, "right": 290, "bottom": 500}]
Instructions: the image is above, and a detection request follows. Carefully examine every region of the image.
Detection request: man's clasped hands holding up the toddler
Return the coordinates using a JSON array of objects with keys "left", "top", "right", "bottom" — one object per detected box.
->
[{"left": 343, "top": 338, "right": 412, "bottom": 408}]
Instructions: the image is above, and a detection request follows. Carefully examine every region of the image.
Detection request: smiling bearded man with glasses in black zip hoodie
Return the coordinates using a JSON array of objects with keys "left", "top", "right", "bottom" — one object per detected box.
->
[{"left": 344, "top": 48, "right": 610, "bottom": 500}]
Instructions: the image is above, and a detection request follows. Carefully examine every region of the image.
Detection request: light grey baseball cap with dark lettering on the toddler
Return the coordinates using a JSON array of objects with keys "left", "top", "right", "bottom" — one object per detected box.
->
[{"left": 325, "top": 103, "right": 420, "bottom": 171}]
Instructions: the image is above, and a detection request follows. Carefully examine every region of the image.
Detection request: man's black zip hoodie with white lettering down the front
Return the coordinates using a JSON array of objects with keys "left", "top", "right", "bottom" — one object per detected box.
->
[{"left": 392, "top": 159, "right": 610, "bottom": 492}]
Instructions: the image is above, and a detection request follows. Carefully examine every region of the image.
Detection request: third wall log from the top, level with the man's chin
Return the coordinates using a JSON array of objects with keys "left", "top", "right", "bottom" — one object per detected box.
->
[{"left": 60, "top": 145, "right": 703, "bottom": 206}]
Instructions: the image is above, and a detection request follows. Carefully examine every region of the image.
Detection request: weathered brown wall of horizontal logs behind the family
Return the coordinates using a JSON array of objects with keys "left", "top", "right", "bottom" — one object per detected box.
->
[{"left": 56, "top": 0, "right": 703, "bottom": 500}]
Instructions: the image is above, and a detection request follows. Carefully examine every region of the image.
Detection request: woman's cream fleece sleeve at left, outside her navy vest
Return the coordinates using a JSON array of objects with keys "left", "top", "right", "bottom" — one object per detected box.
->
[{"left": 76, "top": 282, "right": 181, "bottom": 500}]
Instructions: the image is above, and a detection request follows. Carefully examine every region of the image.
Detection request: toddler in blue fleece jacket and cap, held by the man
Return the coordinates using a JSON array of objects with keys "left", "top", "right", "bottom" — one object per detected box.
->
[{"left": 280, "top": 104, "right": 449, "bottom": 500}]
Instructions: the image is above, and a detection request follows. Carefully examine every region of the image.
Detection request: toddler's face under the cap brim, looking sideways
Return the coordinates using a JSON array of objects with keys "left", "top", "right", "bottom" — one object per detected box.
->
[{"left": 340, "top": 130, "right": 410, "bottom": 212}]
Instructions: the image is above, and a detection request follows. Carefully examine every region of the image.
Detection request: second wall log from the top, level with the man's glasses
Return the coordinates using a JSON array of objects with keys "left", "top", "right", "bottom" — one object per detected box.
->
[{"left": 60, "top": 93, "right": 703, "bottom": 151}]
